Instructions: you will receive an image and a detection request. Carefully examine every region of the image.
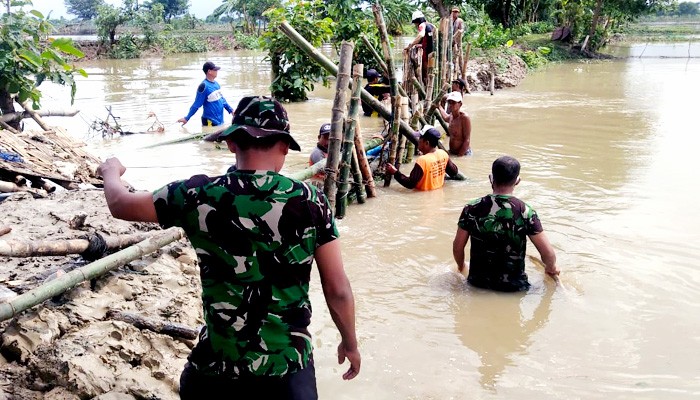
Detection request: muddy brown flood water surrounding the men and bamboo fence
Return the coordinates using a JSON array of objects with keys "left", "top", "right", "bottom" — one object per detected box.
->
[{"left": 35, "top": 44, "right": 700, "bottom": 399}]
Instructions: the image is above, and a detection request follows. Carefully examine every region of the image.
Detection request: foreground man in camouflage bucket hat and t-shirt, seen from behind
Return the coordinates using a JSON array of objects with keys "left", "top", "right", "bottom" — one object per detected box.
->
[{"left": 98, "top": 96, "right": 361, "bottom": 399}]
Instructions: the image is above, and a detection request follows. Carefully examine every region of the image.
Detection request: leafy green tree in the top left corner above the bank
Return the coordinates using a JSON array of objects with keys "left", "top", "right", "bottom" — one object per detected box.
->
[{"left": 0, "top": 7, "right": 87, "bottom": 129}]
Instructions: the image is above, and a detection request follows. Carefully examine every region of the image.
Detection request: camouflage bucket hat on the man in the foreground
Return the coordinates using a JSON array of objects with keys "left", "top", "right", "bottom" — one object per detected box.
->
[{"left": 216, "top": 96, "right": 301, "bottom": 151}]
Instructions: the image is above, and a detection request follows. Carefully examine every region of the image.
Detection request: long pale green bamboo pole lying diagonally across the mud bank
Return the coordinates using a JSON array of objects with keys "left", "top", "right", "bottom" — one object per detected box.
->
[{"left": 0, "top": 228, "right": 184, "bottom": 321}]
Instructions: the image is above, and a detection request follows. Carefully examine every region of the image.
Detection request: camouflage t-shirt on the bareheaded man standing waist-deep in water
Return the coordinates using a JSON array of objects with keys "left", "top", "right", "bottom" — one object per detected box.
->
[{"left": 457, "top": 194, "right": 542, "bottom": 292}]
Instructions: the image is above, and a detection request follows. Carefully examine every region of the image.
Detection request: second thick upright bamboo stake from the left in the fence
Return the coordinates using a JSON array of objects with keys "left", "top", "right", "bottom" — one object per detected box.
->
[{"left": 335, "top": 60, "right": 364, "bottom": 218}]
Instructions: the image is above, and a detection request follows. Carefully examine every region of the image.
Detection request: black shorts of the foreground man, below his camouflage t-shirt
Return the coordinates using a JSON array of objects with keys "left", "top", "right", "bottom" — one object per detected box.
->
[{"left": 180, "top": 360, "right": 318, "bottom": 400}]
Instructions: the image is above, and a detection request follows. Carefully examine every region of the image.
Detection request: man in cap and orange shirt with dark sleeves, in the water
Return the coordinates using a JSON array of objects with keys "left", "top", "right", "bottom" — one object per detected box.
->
[{"left": 386, "top": 125, "right": 459, "bottom": 190}]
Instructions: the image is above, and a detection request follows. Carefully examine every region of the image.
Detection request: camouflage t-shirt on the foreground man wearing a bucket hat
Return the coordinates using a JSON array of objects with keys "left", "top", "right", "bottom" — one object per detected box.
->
[{"left": 153, "top": 170, "right": 338, "bottom": 376}]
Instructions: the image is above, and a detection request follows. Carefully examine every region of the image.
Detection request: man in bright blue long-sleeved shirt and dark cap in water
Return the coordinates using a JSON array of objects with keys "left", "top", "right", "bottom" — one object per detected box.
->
[{"left": 177, "top": 61, "right": 233, "bottom": 126}]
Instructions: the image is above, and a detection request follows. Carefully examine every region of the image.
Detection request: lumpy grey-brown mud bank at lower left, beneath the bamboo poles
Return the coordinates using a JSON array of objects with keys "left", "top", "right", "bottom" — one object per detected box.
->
[{"left": 0, "top": 191, "right": 203, "bottom": 400}]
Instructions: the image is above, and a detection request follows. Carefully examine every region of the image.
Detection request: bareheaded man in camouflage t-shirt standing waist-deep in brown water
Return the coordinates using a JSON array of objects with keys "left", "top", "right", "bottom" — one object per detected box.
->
[{"left": 452, "top": 156, "right": 559, "bottom": 292}]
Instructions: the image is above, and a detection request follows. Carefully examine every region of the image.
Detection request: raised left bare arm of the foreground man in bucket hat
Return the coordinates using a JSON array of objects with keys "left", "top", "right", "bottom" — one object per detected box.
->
[{"left": 97, "top": 158, "right": 158, "bottom": 222}]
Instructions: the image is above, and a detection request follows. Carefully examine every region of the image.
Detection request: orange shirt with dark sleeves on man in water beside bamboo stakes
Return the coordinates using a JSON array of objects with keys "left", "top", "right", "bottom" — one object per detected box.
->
[{"left": 394, "top": 149, "right": 458, "bottom": 190}]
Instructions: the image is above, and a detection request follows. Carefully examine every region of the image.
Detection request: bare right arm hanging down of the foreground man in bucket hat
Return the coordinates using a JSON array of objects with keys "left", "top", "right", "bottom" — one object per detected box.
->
[{"left": 314, "top": 239, "right": 361, "bottom": 380}]
